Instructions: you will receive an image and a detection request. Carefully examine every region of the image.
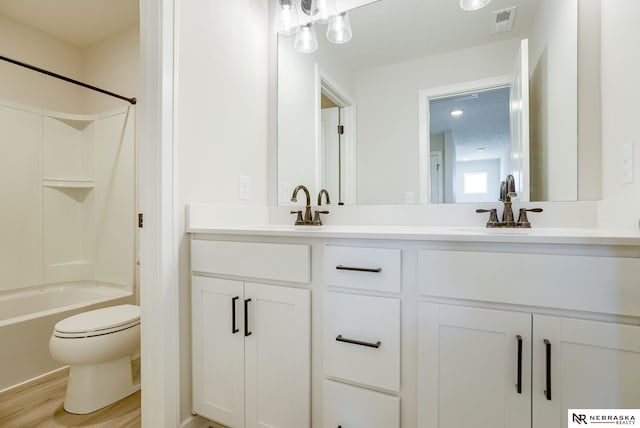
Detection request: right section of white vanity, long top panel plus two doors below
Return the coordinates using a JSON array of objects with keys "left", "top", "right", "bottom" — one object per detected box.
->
[{"left": 418, "top": 247, "right": 640, "bottom": 428}]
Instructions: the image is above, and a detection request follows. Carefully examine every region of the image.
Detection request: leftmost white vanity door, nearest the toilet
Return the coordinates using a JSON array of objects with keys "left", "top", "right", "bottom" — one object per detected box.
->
[{"left": 191, "top": 276, "right": 244, "bottom": 428}]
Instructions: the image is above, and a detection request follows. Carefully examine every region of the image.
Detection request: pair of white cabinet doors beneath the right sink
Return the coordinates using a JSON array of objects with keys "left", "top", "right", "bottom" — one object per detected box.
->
[{"left": 418, "top": 303, "right": 640, "bottom": 428}]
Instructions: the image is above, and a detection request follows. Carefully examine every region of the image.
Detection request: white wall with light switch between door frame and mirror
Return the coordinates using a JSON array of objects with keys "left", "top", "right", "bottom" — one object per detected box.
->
[{"left": 174, "top": 0, "right": 269, "bottom": 420}]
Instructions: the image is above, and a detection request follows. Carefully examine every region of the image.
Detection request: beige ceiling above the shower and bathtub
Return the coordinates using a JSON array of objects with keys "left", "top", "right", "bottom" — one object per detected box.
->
[{"left": 0, "top": 0, "right": 140, "bottom": 48}]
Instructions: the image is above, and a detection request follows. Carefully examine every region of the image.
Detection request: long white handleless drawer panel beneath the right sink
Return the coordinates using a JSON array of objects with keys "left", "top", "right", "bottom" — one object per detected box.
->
[{"left": 418, "top": 250, "right": 640, "bottom": 316}]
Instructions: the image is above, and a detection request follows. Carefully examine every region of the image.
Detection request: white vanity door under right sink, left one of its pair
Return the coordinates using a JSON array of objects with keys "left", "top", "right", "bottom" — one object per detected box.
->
[{"left": 418, "top": 303, "right": 531, "bottom": 428}]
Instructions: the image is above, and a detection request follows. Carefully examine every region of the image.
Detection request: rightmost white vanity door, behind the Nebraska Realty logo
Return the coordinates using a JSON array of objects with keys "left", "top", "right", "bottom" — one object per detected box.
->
[{"left": 533, "top": 315, "right": 640, "bottom": 428}]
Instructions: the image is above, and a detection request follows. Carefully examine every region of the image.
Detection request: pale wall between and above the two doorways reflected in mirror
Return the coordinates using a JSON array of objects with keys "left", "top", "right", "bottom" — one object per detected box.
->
[{"left": 356, "top": 40, "right": 519, "bottom": 204}]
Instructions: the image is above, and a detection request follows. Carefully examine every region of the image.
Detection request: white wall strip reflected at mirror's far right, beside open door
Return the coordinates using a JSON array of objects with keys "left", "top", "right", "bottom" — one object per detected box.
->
[{"left": 529, "top": 0, "right": 578, "bottom": 201}]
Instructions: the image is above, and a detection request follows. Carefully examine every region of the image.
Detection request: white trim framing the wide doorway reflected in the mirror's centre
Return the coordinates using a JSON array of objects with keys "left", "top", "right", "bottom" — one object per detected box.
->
[{"left": 418, "top": 74, "right": 513, "bottom": 204}]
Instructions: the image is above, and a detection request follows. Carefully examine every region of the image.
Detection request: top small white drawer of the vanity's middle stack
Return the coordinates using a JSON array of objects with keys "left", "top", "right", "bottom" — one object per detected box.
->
[{"left": 324, "top": 245, "right": 401, "bottom": 293}]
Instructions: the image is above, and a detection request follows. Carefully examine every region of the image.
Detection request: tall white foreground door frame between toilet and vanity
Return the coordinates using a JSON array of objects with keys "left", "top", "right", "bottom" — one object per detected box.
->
[{"left": 138, "top": 0, "right": 184, "bottom": 428}]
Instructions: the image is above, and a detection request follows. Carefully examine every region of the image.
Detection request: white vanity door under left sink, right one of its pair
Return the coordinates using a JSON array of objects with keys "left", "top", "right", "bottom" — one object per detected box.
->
[{"left": 245, "top": 283, "right": 311, "bottom": 428}]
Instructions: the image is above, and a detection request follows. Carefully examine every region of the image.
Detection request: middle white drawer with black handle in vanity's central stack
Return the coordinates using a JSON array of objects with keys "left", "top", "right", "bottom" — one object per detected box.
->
[{"left": 323, "top": 292, "right": 400, "bottom": 391}]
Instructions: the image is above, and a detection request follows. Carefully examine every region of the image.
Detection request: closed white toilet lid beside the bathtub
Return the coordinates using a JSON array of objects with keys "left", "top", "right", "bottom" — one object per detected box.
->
[{"left": 54, "top": 305, "right": 140, "bottom": 338}]
